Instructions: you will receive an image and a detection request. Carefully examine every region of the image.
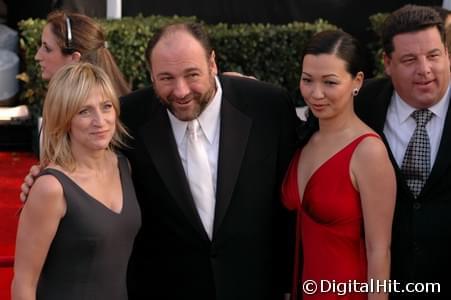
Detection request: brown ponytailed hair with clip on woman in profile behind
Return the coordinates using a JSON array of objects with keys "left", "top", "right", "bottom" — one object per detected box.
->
[{"left": 47, "top": 11, "right": 130, "bottom": 96}]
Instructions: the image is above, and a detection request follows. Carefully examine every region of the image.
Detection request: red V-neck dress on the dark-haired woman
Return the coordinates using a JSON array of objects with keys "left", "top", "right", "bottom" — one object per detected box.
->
[{"left": 282, "top": 134, "right": 378, "bottom": 300}]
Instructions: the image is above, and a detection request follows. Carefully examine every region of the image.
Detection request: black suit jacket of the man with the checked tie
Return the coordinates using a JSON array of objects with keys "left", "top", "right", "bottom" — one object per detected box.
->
[{"left": 355, "top": 78, "right": 451, "bottom": 299}]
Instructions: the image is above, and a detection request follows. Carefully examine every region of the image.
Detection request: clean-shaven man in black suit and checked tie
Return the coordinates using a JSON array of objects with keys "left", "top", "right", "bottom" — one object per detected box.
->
[{"left": 356, "top": 5, "right": 451, "bottom": 299}]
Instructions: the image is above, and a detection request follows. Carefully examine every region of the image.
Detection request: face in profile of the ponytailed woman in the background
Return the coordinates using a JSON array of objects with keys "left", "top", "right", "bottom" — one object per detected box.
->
[{"left": 34, "top": 24, "right": 73, "bottom": 80}]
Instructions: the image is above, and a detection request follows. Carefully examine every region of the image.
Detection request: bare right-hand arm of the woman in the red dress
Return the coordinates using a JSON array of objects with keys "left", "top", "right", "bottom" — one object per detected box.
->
[{"left": 351, "top": 138, "right": 396, "bottom": 300}]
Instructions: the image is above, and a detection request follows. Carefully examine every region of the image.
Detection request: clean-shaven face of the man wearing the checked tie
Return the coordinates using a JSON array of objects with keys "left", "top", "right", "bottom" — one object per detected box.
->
[{"left": 384, "top": 27, "right": 450, "bottom": 109}]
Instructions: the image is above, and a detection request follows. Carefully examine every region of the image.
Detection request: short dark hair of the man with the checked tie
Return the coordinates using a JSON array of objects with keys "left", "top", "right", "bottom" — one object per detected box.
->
[{"left": 382, "top": 4, "right": 446, "bottom": 56}]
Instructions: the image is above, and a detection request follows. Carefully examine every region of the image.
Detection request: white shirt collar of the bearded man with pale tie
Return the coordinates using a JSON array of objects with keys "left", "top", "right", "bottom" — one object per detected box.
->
[{"left": 167, "top": 76, "right": 222, "bottom": 146}]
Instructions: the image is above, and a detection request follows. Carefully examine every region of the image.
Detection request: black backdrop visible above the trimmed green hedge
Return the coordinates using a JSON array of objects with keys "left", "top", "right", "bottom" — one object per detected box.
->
[{"left": 0, "top": 0, "right": 442, "bottom": 77}]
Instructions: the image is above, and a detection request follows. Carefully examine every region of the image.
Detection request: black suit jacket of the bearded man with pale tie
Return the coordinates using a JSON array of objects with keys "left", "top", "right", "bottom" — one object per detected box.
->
[{"left": 122, "top": 77, "right": 297, "bottom": 300}]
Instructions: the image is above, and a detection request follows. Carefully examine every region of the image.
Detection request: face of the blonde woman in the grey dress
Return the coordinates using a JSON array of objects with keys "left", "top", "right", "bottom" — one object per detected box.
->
[{"left": 69, "top": 88, "right": 117, "bottom": 153}]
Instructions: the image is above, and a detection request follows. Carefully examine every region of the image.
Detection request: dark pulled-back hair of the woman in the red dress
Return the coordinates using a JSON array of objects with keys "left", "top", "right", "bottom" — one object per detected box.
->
[{"left": 300, "top": 30, "right": 366, "bottom": 144}]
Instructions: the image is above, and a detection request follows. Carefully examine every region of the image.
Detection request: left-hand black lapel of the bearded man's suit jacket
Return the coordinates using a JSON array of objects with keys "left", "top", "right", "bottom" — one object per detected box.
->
[{"left": 139, "top": 105, "right": 208, "bottom": 239}]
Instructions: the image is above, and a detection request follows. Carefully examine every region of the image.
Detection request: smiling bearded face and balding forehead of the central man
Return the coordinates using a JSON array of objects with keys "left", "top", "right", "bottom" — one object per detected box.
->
[{"left": 150, "top": 30, "right": 217, "bottom": 121}]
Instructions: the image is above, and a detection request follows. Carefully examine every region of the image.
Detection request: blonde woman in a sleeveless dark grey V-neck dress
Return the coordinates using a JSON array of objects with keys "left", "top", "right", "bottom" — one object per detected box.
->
[{"left": 12, "top": 63, "right": 141, "bottom": 300}]
